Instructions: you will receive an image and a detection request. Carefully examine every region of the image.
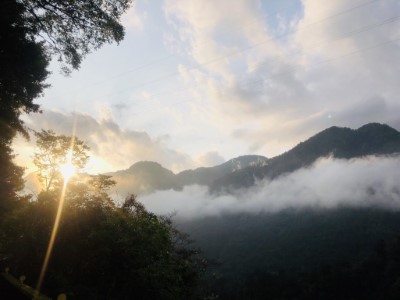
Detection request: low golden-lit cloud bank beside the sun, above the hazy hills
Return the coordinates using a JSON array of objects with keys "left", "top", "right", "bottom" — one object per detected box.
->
[{"left": 14, "top": 111, "right": 194, "bottom": 172}]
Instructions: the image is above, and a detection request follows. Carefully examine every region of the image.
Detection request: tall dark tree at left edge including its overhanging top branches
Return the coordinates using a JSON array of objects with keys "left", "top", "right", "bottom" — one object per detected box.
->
[{"left": 0, "top": 0, "right": 132, "bottom": 209}]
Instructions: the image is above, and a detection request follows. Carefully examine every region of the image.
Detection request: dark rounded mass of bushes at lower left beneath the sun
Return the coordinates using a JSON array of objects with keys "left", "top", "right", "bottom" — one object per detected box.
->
[{"left": 0, "top": 190, "right": 202, "bottom": 299}]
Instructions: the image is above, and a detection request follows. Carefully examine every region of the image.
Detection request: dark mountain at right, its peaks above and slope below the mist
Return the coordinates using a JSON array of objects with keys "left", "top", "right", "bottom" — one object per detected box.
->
[{"left": 173, "top": 123, "right": 400, "bottom": 300}]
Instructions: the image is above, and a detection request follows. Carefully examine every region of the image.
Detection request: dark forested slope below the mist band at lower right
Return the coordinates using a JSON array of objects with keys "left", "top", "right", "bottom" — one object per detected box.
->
[{"left": 178, "top": 208, "right": 400, "bottom": 299}]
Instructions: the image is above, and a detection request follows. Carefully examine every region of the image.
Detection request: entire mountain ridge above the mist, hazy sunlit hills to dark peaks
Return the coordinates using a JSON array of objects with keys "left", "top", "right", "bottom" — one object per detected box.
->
[{"left": 26, "top": 123, "right": 400, "bottom": 196}]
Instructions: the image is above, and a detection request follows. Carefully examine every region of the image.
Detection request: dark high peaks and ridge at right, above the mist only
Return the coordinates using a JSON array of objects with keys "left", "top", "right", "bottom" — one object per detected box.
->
[{"left": 211, "top": 123, "right": 400, "bottom": 192}]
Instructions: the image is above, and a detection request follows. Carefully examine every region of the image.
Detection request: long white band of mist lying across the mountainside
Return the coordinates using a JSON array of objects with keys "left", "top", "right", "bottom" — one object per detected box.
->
[{"left": 139, "top": 156, "right": 400, "bottom": 219}]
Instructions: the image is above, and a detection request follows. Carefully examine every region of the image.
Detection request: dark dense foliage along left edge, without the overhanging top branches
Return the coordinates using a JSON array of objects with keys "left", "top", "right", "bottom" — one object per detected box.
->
[{"left": 0, "top": 0, "right": 48, "bottom": 214}]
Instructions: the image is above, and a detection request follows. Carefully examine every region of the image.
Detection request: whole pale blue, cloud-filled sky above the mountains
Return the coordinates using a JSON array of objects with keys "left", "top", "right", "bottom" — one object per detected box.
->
[{"left": 14, "top": 0, "right": 400, "bottom": 173}]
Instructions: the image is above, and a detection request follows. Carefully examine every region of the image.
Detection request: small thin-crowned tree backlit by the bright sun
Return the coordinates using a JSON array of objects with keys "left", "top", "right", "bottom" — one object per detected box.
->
[{"left": 33, "top": 130, "right": 89, "bottom": 191}]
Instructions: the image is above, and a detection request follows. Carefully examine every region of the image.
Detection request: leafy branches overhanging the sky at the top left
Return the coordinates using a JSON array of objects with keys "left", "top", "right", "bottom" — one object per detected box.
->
[{"left": 17, "top": 0, "right": 132, "bottom": 69}]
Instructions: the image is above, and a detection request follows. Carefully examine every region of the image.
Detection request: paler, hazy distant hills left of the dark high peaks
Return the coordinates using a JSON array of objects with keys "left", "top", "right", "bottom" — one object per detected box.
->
[{"left": 107, "top": 155, "right": 267, "bottom": 196}]
